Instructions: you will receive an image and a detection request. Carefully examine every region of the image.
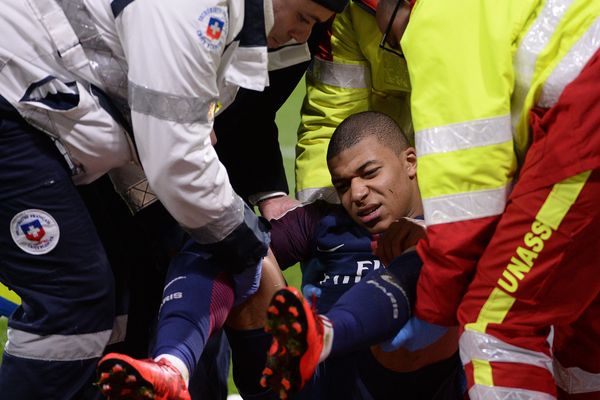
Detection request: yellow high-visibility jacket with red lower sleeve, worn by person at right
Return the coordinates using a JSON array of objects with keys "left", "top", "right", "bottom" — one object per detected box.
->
[{"left": 401, "top": 0, "right": 600, "bottom": 325}]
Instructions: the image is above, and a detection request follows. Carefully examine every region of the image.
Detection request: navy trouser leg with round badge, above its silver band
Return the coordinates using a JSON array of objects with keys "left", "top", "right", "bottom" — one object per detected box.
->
[{"left": 0, "top": 95, "right": 113, "bottom": 340}]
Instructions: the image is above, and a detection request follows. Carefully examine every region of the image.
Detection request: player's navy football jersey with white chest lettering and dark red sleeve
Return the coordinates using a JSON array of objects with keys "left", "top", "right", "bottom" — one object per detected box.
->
[{"left": 271, "top": 201, "right": 382, "bottom": 313}]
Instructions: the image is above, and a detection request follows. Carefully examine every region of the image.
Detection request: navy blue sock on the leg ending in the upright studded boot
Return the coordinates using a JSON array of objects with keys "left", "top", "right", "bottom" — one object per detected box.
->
[{"left": 325, "top": 252, "right": 421, "bottom": 355}]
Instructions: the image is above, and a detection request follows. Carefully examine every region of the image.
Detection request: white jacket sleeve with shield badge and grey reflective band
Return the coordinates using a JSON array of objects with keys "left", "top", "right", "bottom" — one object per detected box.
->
[{"left": 117, "top": 0, "right": 244, "bottom": 243}]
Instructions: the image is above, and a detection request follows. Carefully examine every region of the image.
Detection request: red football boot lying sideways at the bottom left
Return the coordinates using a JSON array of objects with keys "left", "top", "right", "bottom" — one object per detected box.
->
[{"left": 97, "top": 353, "right": 191, "bottom": 400}]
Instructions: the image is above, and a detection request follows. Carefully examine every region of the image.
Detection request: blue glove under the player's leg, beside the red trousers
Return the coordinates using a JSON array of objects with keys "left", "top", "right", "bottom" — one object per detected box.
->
[{"left": 381, "top": 317, "right": 448, "bottom": 351}]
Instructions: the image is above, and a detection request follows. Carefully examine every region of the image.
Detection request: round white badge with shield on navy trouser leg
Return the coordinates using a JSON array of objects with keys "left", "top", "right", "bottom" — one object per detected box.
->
[{"left": 10, "top": 209, "right": 60, "bottom": 255}]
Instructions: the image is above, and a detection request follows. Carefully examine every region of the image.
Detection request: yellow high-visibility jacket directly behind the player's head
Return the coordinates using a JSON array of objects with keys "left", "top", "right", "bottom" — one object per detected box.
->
[{"left": 296, "top": 1, "right": 412, "bottom": 202}]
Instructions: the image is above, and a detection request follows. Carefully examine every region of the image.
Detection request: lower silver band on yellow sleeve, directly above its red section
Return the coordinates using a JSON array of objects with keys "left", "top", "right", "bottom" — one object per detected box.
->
[{"left": 423, "top": 182, "right": 512, "bottom": 225}]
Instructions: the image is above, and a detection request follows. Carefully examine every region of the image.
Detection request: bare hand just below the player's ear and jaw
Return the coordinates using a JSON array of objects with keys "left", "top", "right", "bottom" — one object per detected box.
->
[{"left": 374, "top": 218, "right": 426, "bottom": 265}]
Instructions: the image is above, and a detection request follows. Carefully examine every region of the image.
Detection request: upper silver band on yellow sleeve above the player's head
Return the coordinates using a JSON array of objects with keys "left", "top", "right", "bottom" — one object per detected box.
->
[{"left": 308, "top": 57, "right": 371, "bottom": 89}]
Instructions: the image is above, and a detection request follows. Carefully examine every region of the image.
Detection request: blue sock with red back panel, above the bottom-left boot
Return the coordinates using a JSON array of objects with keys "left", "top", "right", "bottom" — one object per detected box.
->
[{"left": 151, "top": 242, "right": 234, "bottom": 375}]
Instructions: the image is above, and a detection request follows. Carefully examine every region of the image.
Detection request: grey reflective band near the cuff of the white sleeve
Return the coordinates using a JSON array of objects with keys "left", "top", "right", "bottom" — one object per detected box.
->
[{"left": 185, "top": 193, "right": 244, "bottom": 243}]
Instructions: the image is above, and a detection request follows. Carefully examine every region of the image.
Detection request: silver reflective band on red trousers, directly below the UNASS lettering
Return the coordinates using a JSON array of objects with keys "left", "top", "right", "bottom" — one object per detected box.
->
[{"left": 459, "top": 329, "right": 552, "bottom": 373}]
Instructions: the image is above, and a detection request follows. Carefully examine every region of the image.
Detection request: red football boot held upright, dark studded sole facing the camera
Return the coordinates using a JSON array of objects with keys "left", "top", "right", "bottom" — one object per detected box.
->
[{"left": 261, "top": 287, "right": 323, "bottom": 399}]
